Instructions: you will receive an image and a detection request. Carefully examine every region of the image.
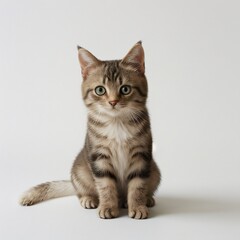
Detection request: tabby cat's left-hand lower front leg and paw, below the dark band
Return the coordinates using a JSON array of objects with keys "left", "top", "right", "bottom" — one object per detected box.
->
[{"left": 96, "top": 177, "right": 119, "bottom": 219}]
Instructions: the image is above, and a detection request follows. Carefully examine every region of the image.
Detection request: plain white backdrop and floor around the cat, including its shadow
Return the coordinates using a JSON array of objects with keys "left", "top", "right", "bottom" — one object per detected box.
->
[{"left": 0, "top": 0, "right": 240, "bottom": 240}]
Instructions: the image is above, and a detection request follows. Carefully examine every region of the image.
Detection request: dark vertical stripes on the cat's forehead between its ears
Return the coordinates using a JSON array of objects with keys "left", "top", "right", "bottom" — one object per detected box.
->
[{"left": 103, "top": 60, "right": 122, "bottom": 85}]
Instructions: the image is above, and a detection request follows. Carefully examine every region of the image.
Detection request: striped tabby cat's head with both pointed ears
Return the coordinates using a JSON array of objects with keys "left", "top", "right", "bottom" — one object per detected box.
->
[{"left": 78, "top": 42, "right": 148, "bottom": 116}]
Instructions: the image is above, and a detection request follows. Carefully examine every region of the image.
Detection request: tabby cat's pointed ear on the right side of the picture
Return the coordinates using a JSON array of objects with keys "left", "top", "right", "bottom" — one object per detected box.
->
[{"left": 121, "top": 41, "right": 145, "bottom": 74}]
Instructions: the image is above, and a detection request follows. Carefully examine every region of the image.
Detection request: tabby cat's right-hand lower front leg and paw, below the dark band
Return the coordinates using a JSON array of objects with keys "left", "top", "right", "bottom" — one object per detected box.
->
[{"left": 128, "top": 177, "right": 149, "bottom": 219}]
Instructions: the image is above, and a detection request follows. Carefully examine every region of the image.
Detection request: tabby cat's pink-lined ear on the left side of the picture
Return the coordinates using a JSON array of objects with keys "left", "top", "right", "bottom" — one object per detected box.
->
[{"left": 77, "top": 46, "right": 101, "bottom": 80}]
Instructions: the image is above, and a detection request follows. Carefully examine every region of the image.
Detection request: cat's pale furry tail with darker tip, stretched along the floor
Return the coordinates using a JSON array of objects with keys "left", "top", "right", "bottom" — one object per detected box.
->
[{"left": 19, "top": 181, "right": 76, "bottom": 206}]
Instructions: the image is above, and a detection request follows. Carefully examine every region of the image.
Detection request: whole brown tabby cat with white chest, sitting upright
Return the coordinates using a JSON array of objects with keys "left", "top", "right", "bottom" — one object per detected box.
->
[{"left": 20, "top": 42, "right": 161, "bottom": 219}]
